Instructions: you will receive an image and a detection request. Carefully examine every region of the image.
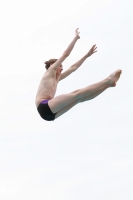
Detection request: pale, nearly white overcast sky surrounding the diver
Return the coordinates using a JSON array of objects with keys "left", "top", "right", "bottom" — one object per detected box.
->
[{"left": 0, "top": 0, "right": 133, "bottom": 200}]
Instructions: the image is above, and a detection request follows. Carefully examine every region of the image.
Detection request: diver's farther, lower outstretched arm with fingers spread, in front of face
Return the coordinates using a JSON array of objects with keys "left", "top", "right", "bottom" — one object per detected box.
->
[{"left": 60, "top": 45, "right": 97, "bottom": 80}]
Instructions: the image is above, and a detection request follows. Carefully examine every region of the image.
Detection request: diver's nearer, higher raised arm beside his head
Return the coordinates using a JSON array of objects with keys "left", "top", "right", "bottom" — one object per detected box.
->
[{"left": 50, "top": 29, "right": 80, "bottom": 70}]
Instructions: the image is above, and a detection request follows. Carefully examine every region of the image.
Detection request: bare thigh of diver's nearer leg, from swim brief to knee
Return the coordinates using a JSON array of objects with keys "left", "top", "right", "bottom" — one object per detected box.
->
[{"left": 48, "top": 90, "right": 80, "bottom": 113}]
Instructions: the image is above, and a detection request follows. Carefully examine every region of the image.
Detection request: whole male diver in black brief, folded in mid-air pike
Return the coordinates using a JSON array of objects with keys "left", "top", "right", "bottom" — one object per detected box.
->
[{"left": 35, "top": 29, "right": 122, "bottom": 121}]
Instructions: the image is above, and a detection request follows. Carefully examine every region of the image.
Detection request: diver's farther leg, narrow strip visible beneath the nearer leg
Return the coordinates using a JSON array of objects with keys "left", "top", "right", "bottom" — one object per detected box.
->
[{"left": 55, "top": 86, "right": 108, "bottom": 119}]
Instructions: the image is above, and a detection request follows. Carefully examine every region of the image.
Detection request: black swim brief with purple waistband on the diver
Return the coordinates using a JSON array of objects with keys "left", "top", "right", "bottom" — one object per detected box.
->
[{"left": 37, "top": 99, "right": 56, "bottom": 121}]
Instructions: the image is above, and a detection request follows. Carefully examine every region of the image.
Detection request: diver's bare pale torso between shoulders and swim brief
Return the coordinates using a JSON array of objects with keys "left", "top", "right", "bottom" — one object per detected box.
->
[{"left": 35, "top": 70, "right": 60, "bottom": 107}]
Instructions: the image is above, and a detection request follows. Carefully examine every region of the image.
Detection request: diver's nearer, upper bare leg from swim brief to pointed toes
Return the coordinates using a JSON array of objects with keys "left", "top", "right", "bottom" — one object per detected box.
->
[{"left": 48, "top": 70, "right": 121, "bottom": 113}]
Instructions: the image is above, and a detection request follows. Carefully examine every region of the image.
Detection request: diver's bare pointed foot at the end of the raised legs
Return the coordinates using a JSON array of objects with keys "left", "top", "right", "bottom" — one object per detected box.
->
[{"left": 108, "top": 69, "right": 122, "bottom": 87}]
